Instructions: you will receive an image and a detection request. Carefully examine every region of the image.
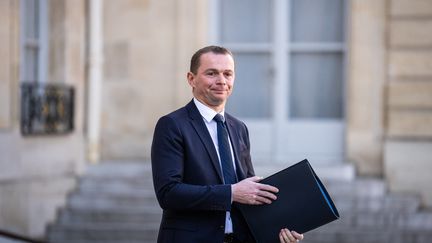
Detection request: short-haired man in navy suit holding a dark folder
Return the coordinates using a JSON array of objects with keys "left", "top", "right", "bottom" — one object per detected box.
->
[{"left": 151, "top": 46, "right": 303, "bottom": 243}]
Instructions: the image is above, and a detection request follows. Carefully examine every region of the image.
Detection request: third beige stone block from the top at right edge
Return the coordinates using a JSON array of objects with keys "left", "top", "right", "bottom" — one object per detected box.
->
[{"left": 389, "top": 49, "right": 432, "bottom": 78}]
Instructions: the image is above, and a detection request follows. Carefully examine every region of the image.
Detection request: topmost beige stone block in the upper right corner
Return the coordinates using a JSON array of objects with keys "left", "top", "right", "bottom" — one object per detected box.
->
[{"left": 389, "top": 0, "right": 432, "bottom": 17}]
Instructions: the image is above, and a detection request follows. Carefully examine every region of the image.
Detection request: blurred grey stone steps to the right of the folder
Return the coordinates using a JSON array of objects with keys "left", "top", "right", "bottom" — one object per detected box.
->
[{"left": 304, "top": 179, "right": 432, "bottom": 243}]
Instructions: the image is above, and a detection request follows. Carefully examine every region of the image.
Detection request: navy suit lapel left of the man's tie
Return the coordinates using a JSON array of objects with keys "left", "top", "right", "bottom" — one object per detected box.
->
[{"left": 186, "top": 101, "right": 223, "bottom": 182}]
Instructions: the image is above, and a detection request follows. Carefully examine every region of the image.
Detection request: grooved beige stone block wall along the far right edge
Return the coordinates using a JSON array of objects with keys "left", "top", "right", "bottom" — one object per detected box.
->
[{"left": 384, "top": 0, "right": 432, "bottom": 206}]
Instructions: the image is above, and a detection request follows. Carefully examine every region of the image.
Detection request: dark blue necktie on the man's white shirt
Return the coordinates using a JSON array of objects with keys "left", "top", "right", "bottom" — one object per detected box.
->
[{"left": 213, "top": 114, "right": 237, "bottom": 184}]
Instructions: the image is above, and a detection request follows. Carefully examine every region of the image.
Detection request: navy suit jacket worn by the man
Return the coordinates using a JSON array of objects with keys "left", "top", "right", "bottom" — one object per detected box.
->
[{"left": 151, "top": 101, "right": 254, "bottom": 243}]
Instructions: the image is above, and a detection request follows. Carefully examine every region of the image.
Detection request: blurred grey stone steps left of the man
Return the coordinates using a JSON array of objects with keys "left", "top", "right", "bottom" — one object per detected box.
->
[{"left": 47, "top": 162, "right": 162, "bottom": 243}]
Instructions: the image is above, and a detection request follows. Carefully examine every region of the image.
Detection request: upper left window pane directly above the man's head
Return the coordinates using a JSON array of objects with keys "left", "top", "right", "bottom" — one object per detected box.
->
[{"left": 220, "top": 0, "right": 272, "bottom": 43}]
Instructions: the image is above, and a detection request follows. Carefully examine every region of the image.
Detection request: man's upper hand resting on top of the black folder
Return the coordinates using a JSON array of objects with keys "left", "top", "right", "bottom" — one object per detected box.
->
[{"left": 231, "top": 176, "right": 279, "bottom": 205}]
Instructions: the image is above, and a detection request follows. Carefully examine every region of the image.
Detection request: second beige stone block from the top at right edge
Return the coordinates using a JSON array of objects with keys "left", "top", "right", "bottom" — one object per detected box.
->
[{"left": 389, "top": 19, "right": 432, "bottom": 48}]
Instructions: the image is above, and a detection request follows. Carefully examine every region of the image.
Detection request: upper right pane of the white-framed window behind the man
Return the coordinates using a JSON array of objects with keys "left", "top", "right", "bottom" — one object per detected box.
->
[{"left": 291, "top": 0, "right": 344, "bottom": 42}]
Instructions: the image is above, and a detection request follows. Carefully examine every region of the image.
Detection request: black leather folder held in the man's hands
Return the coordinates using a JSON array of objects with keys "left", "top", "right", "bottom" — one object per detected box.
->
[{"left": 236, "top": 159, "right": 339, "bottom": 243}]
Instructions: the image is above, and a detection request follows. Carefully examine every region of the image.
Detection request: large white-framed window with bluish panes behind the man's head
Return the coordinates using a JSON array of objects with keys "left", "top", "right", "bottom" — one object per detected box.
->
[{"left": 212, "top": 0, "right": 347, "bottom": 120}]
